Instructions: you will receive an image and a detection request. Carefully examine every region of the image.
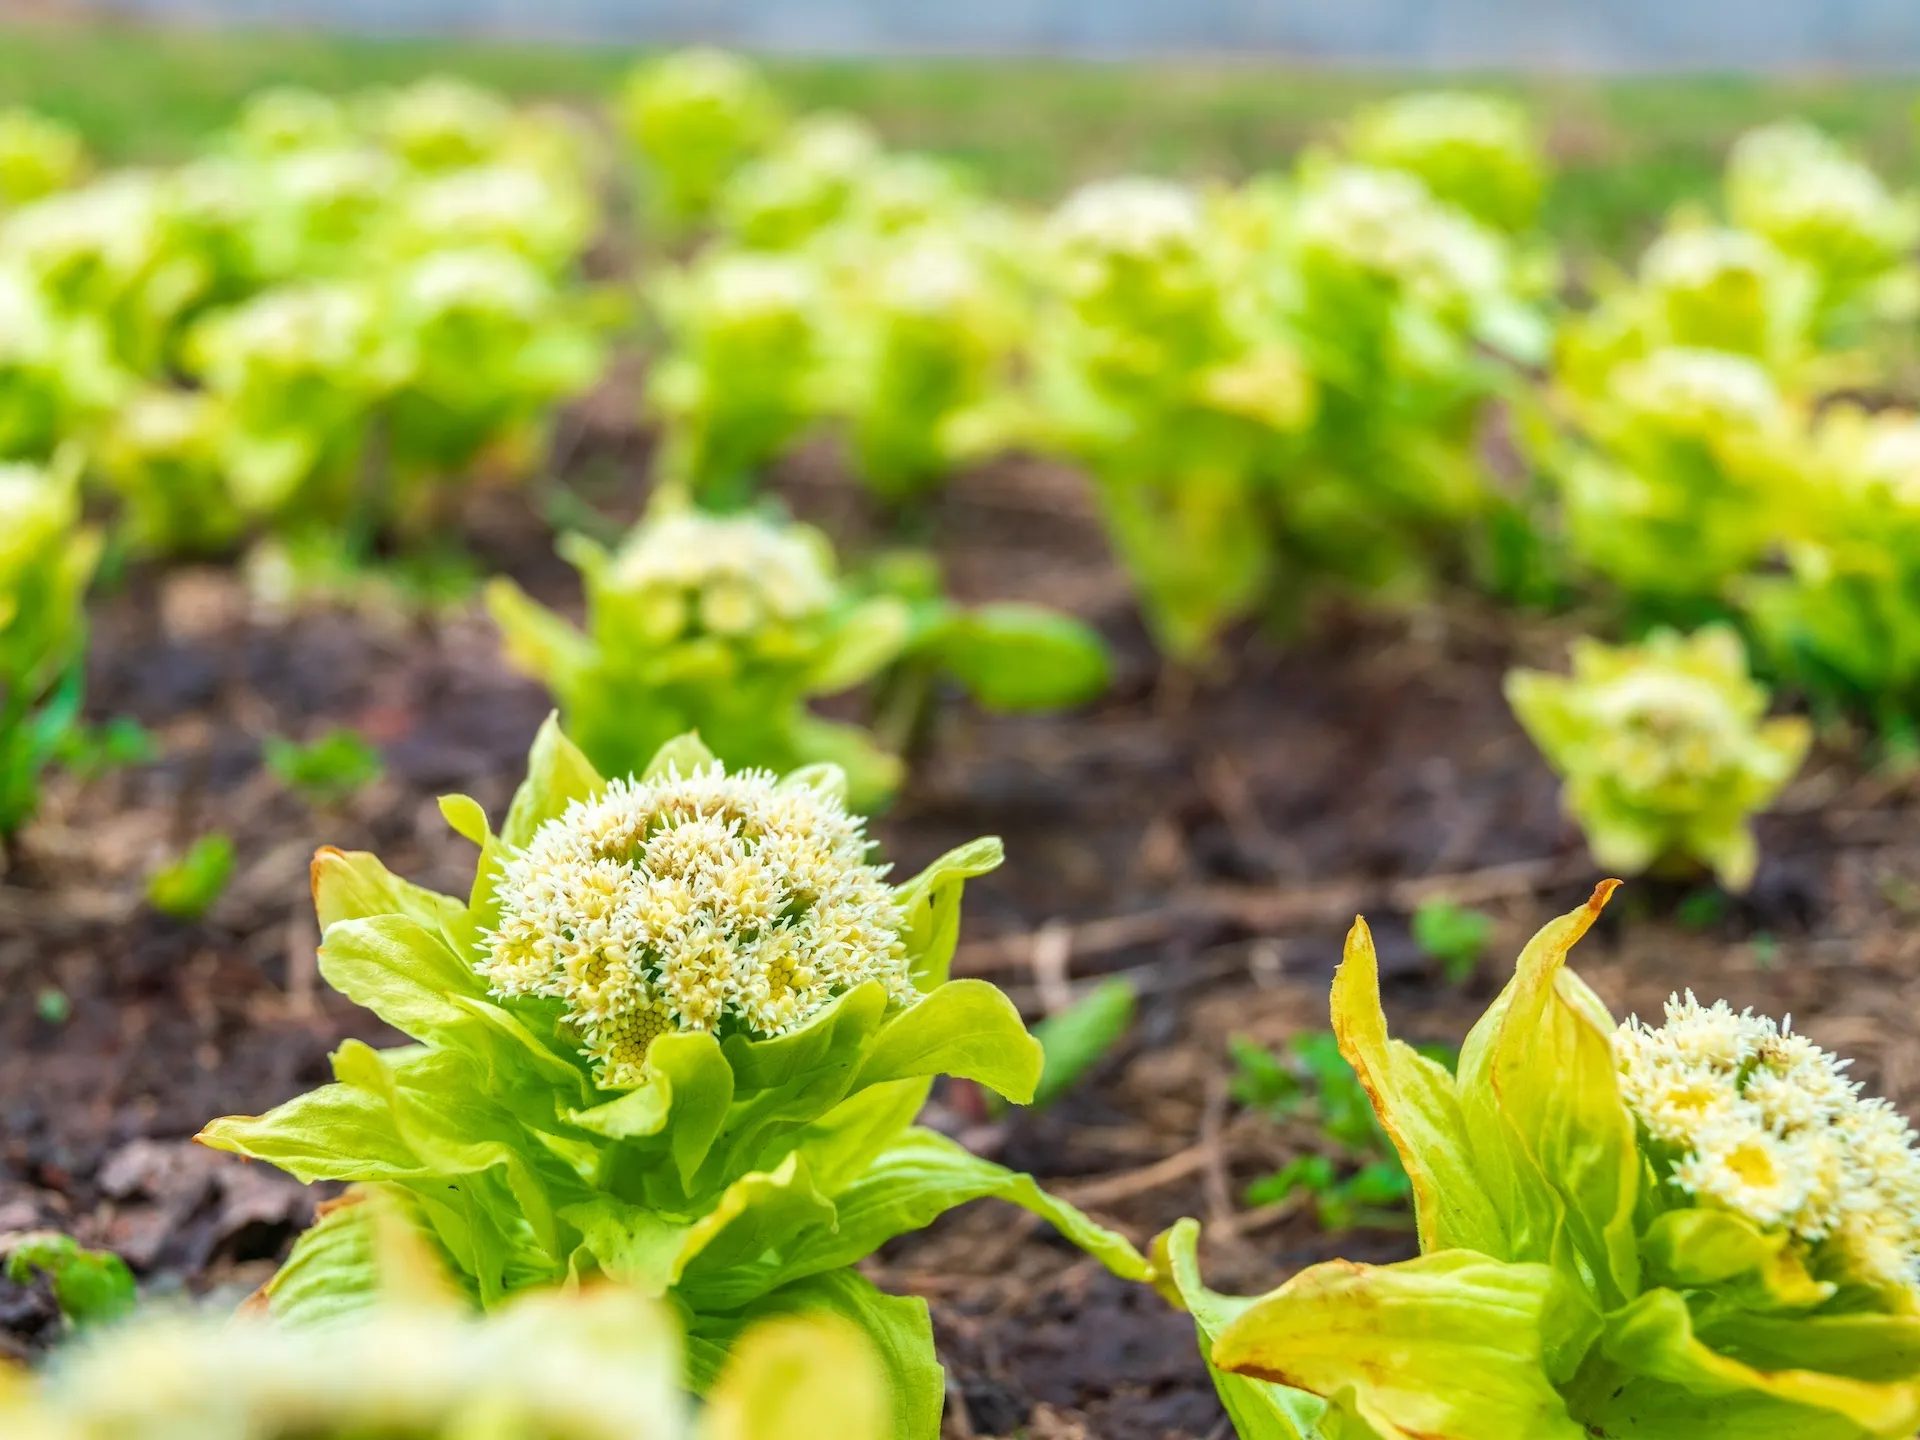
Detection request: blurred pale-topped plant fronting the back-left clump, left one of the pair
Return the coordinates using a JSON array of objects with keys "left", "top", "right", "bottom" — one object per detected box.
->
[{"left": 186, "top": 282, "right": 405, "bottom": 524}]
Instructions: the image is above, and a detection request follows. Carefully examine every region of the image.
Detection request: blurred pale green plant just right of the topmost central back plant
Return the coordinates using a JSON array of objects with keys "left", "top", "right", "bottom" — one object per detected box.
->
[{"left": 718, "top": 109, "right": 883, "bottom": 250}]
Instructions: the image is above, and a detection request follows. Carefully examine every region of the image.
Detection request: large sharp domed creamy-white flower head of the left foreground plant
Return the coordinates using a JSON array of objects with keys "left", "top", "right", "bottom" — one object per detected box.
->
[{"left": 478, "top": 764, "right": 916, "bottom": 1087}]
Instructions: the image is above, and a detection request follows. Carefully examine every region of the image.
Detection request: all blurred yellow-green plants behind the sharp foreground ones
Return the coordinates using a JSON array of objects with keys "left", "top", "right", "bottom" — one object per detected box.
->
[{"left": 15, "top": 52, "right": 1920, "bottom": 887}]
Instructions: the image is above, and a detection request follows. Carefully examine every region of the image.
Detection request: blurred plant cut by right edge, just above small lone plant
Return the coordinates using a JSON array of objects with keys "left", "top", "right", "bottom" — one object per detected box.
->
[{"left": 1738, "top": 405, "right": 1920, "bottom": 735}]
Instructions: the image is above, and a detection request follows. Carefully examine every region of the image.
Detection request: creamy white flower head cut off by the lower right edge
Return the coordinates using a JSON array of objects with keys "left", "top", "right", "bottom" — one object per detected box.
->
[{"left": 1613, "top": 991, "right": 1920, "bottom": 1290}]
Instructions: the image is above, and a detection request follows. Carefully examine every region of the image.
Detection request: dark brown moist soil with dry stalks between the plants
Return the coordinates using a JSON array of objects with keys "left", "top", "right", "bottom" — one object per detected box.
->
[{"left": 0, "top": 417, "right": 1920, "bottom": 1440}]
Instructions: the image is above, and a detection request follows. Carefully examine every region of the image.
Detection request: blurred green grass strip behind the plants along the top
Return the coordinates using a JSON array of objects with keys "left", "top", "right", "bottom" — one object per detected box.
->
[{"left": 0, "top": 25, "right": 1912, "bottom": 255}]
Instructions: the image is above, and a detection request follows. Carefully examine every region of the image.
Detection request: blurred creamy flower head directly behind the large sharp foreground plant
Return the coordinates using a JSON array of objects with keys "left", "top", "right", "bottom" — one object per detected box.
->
[{"left": 612, "top": 511, "right": 833, "bottom": 645}]
